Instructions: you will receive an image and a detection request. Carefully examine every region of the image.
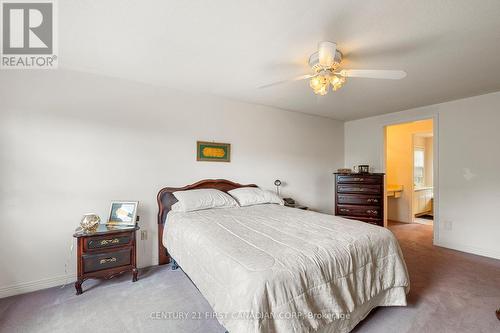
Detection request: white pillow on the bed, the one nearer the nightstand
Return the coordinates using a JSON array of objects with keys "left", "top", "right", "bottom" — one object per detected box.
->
[{"left": 172, "top": 189, "right": 238, "bottom": 212}]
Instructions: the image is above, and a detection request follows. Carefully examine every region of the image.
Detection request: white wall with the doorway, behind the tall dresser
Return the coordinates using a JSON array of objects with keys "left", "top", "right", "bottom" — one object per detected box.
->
[{"left": 345, "top": 93, "right": 500, "bottom": 259}]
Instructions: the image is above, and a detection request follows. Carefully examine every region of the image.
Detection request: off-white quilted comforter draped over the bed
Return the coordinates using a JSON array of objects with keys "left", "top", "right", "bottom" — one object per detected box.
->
[{"left": 163, "top": 205, "right": 409, "bottom": 333}]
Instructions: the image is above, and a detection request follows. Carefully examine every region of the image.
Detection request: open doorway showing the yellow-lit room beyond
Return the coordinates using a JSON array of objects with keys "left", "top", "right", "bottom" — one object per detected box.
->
[{"left": 385, "top": 119, "right": 436, "bottom": 226}]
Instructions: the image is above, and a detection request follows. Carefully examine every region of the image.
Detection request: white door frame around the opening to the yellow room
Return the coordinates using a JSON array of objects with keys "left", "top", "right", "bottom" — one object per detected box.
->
[{"left": 381, "top": 113, "right": 440, "bottom": 244}]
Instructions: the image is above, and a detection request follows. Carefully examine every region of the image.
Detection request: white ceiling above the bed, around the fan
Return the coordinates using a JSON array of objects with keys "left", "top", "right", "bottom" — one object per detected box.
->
[{"left": 58, "top": 0, "right": 500, "bottom": 120}]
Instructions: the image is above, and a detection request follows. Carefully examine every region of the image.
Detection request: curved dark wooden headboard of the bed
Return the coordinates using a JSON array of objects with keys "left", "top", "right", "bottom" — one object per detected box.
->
[{"left": 156, "top": 179, "right": 257, "bottom": 265}]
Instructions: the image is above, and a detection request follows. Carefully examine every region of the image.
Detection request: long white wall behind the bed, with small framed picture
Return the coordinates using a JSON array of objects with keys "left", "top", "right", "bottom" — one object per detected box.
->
[{"left": 0, "top": 70, "right": 344, "bottom": 297}]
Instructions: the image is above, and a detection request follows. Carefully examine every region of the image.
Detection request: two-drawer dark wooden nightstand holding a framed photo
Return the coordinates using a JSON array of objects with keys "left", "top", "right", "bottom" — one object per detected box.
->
[{"left": 73, "top": 224, "right": 139, "bottom": 295}]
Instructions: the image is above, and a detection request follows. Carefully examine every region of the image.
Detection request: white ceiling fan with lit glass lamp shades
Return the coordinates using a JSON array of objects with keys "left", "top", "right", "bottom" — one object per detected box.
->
[{"left": 259, "top": 41, "right": 406, "bottom": 95}]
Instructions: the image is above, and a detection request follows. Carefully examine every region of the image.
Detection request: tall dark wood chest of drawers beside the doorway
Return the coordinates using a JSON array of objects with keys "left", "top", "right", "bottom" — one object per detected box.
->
[{"left": 335, "top": 173, "right": 384, "bottom": 226}]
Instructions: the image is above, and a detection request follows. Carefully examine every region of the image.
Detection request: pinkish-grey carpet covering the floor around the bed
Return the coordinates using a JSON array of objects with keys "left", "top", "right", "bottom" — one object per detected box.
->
[{"left": 0, "top": 220, "right": 500, "bottom": 333}]
